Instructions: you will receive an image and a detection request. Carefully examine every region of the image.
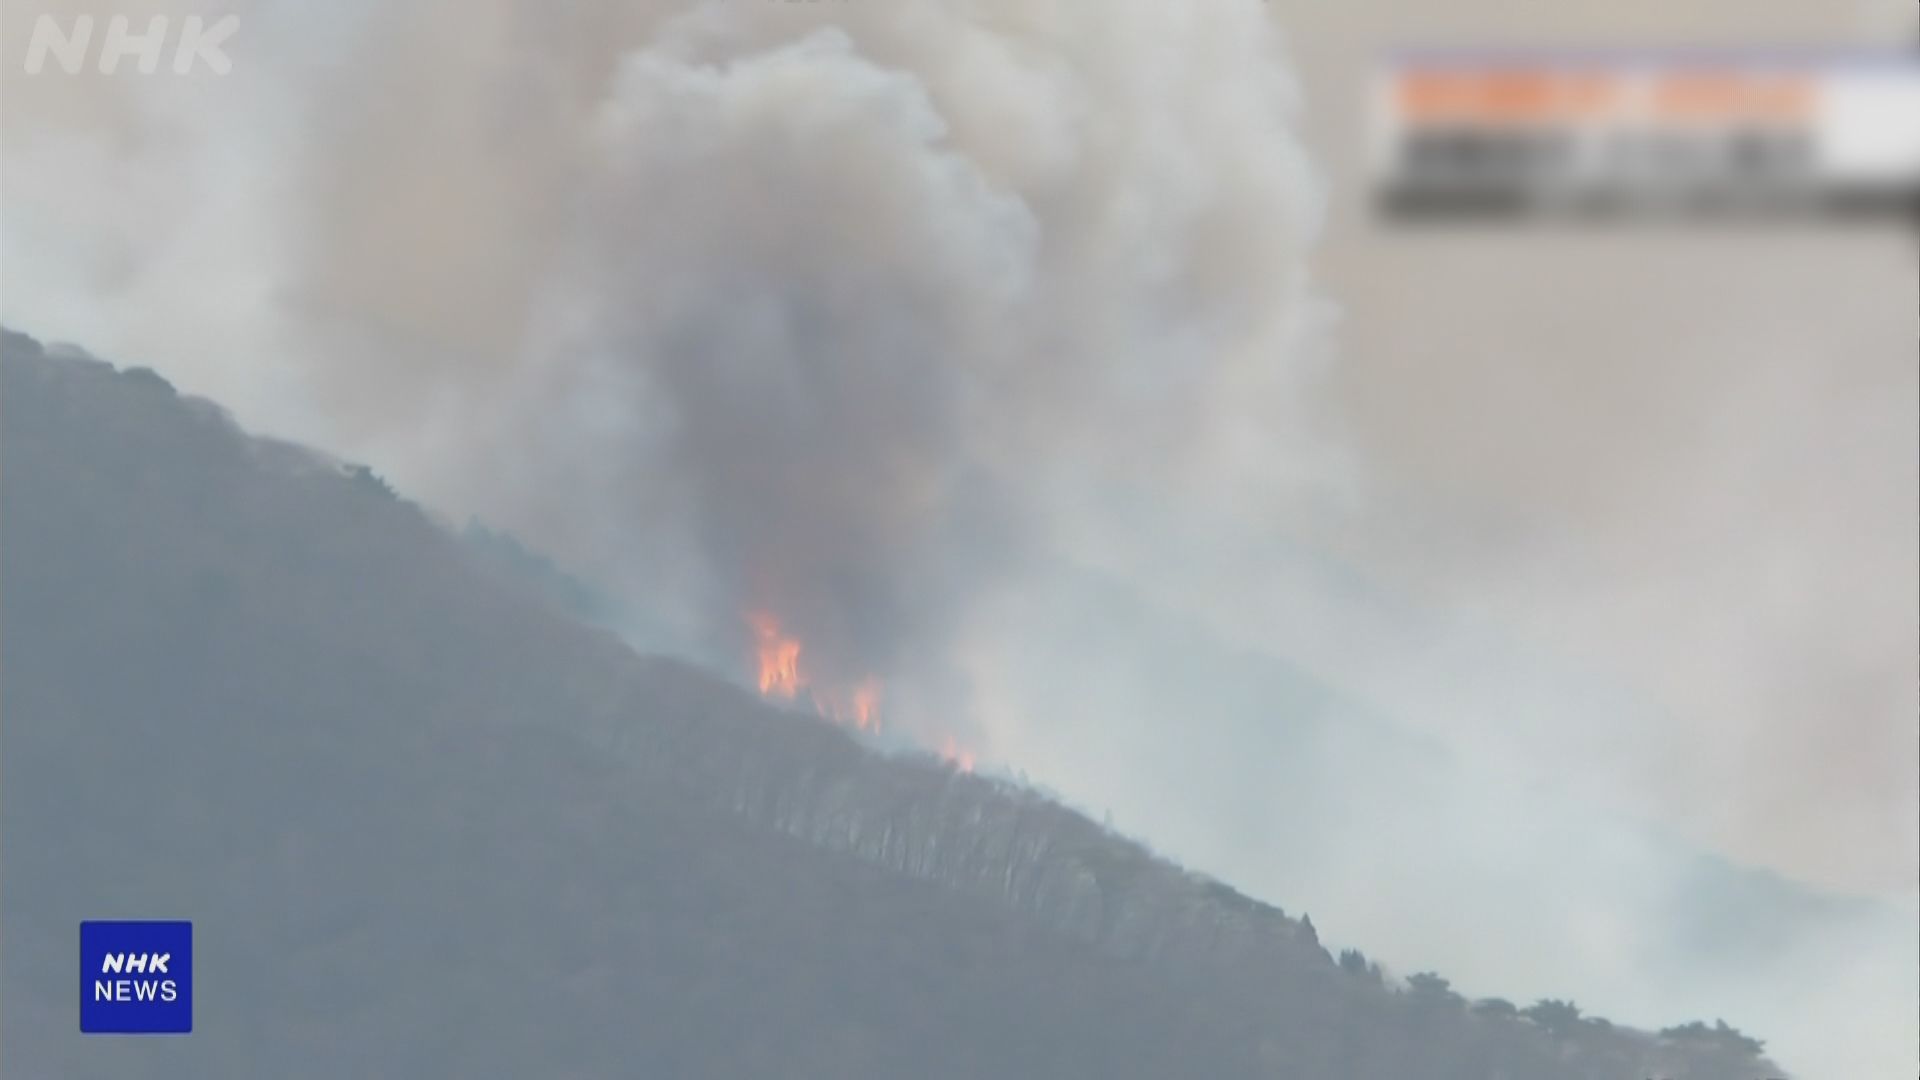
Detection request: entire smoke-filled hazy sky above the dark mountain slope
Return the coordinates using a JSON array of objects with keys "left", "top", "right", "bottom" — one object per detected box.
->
[{"left": 0, "top": 0, "right": 1920, "bottom": 1076}]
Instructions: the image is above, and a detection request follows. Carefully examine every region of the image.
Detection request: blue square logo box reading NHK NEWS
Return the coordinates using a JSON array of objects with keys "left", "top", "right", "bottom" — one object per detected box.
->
[{"left": 81, "top": 922, "right": 194, "bottom": 1036}]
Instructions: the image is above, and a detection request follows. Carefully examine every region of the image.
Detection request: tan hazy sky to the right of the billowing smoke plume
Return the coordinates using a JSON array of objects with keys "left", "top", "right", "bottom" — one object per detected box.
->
[{"left": 1281, "top": 2, "right": 1920, "bottom": 890}]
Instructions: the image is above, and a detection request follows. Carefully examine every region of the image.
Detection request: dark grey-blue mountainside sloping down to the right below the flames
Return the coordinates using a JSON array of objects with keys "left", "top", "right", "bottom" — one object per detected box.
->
[{"left": 0, "top": 332, "right": 1776, "bottom": 1080}]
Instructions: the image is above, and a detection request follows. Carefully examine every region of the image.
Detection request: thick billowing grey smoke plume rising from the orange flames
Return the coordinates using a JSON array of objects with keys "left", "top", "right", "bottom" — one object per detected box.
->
[{"left": 228, "top": 4, "right": 1317, "bottom": 737}]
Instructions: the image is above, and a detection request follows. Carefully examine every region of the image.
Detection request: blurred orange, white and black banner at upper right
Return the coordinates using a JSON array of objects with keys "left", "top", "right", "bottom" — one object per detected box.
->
[{"left": 1369, "top": 48, "right": 1920, "bottom": 221}]
